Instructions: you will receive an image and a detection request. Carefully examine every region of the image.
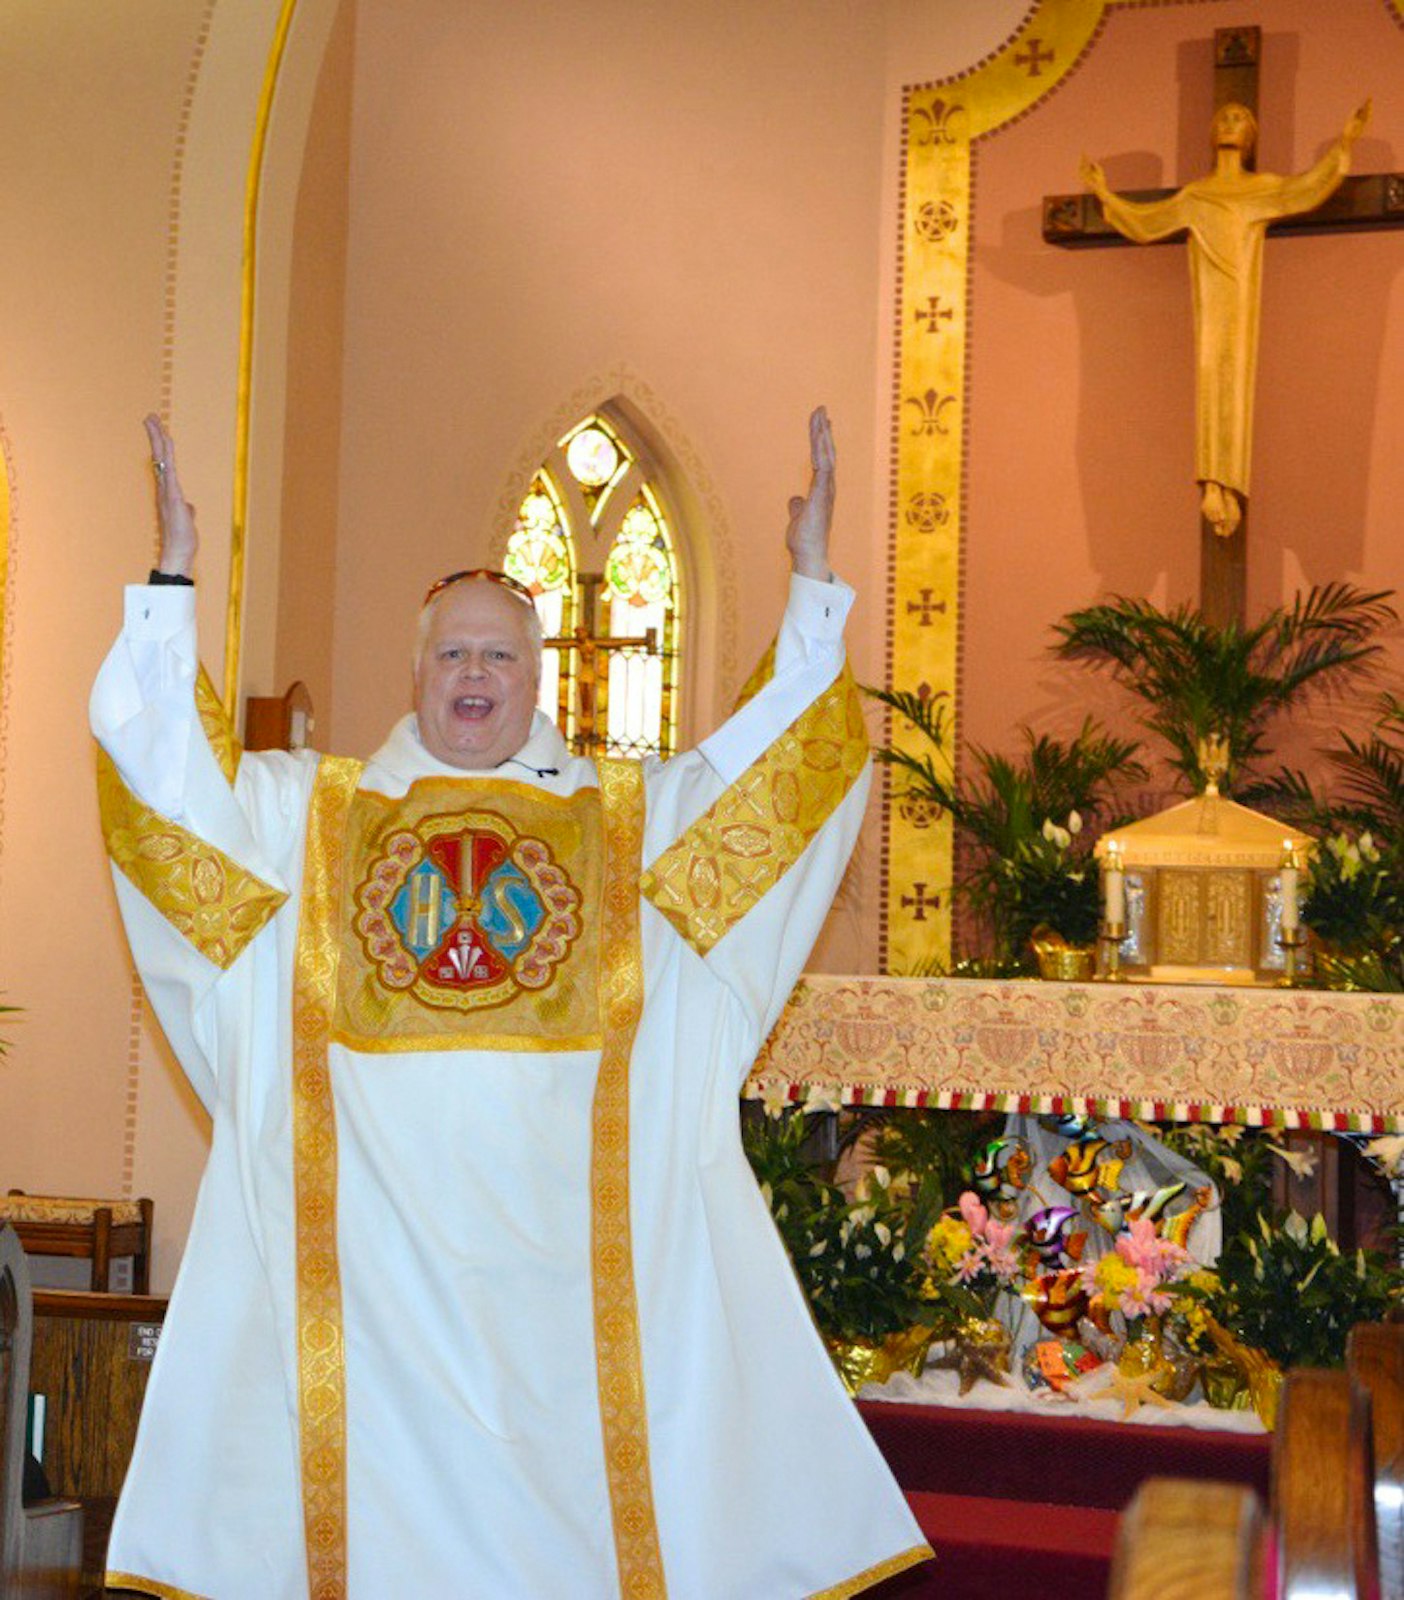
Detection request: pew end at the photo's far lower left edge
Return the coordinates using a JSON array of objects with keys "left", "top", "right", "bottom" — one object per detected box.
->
[{"left": 0, "top": 1226, "right": 83, "bottom": 1600}]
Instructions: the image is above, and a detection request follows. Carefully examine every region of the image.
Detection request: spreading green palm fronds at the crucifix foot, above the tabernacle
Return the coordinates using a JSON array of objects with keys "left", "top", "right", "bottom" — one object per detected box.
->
[{"left": 1054, "top": 582, "right": 1398, "bottom": 794}]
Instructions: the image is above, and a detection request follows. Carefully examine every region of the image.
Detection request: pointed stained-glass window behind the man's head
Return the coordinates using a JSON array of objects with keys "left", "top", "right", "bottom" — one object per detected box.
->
[{"left": 504, "top": 406, "right": 683, "bottom": 757}]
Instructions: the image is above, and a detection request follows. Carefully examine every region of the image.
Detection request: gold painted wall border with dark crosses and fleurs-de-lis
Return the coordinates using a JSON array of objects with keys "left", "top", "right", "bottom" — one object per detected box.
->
[{"left": 878, "top": 0, "right": 1176, "bottom": 973}]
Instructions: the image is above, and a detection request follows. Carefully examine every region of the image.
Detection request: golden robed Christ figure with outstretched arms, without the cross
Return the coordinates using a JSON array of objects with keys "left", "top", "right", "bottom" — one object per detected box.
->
[{"left": 1083, "top": 101, "right": 1370, "bottom": 538}]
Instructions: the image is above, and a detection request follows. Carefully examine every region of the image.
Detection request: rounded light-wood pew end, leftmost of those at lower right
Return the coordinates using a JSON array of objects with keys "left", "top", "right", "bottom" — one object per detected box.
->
[{"left": 1107, "top": 1478, "right": 1263, "bottom": 1600}]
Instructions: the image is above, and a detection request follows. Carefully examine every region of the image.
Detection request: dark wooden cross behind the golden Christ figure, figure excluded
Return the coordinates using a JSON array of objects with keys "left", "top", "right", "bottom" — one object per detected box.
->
[{"left": 1043, "top": 27, "right": 1404, "bottom": 626}]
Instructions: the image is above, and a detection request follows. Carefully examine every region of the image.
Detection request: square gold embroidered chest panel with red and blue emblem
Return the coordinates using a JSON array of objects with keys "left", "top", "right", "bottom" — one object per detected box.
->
[{"left": 342, "top": 778, "right": 604, "bottom": 1051}]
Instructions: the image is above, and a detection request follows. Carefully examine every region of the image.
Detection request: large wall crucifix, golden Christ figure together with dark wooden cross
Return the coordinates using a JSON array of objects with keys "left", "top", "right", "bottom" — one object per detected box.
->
[{"left": 1043, "top": 27, "right": 1404, "bottom": 626}]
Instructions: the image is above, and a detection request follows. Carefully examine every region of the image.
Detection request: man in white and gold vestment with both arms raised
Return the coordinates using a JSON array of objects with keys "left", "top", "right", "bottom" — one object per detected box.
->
[{"left": 93, "top": 411, "right": 931, "bottom": 1600}]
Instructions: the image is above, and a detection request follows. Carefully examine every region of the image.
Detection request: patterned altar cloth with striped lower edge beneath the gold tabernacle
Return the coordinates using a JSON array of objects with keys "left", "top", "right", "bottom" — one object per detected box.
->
[{"left": 744, "top": 974, "right": 1404, "bottom": 1134}]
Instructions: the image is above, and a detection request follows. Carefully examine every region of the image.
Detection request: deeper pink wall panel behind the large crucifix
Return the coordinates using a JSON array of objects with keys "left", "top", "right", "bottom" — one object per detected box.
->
[{"left": 961, "top": 0, "right": 1404, "bottom": 784}]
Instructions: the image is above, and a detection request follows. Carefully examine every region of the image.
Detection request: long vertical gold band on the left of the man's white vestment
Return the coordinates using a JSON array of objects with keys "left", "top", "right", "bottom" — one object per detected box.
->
[{"left": 293, "top": 757, "right": 361, "bottom": 1600}]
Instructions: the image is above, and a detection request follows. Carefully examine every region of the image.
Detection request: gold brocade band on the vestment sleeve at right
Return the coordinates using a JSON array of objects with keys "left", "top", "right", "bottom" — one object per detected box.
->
[{"left": 641, "top": 664, "right": 868, "bottom": 955}]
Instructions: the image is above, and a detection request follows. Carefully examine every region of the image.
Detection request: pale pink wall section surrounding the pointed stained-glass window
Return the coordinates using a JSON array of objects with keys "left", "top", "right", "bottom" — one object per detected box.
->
[{"left": 318, "top": 0, "right": 883, "bottom": 750}]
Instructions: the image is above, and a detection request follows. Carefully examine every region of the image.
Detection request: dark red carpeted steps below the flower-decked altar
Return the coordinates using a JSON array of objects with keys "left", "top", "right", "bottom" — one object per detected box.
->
[{"left": 859, "top": 1402, "right": 1271, "bottom": 1600}]
